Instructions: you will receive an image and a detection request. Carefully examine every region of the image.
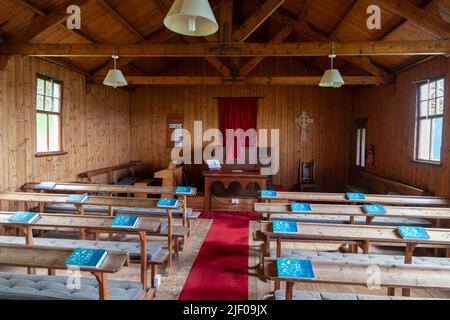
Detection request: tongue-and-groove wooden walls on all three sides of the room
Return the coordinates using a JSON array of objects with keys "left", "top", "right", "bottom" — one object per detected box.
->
[{"left": 0, "top": 57, "right": 450, "bottom": 197}]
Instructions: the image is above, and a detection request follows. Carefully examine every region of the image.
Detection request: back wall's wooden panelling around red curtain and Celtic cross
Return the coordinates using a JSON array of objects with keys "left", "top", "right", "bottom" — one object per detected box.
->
[{"left": 131, "top": 59, "right": 352, "bottom": 191}]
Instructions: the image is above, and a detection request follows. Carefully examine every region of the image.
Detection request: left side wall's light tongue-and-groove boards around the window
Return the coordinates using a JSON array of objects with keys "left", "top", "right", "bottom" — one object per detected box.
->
[{"left": 0, "top": 57, "right": 130, "bottom": 209}]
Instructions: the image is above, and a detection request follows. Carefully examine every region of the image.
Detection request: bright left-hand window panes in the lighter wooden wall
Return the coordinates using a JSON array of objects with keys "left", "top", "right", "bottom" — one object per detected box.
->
[{"left": 36, "top": 75, "right": 62, "bottom": 155}]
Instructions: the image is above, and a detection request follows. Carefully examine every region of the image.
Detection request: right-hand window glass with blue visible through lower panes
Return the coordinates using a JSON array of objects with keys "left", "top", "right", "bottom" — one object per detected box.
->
[{"left": 416, "top": 78, "right": 445, "bottom": 163}]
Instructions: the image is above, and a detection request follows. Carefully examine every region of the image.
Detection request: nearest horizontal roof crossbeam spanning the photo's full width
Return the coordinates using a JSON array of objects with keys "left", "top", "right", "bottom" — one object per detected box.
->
[{"left": 0, "top": 40, "right": 450, "bottom": 57}]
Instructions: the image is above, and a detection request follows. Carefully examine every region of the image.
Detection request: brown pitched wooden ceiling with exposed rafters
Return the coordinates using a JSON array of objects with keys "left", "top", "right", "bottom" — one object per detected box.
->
[{"left": 0, "top": 0, "right": 450, "bottom": 84}]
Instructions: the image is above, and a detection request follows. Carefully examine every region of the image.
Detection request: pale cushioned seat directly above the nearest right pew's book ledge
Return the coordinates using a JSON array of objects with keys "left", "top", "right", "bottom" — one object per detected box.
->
[{"left": 270, "top": 248, "right": 450, "bottom": 268}]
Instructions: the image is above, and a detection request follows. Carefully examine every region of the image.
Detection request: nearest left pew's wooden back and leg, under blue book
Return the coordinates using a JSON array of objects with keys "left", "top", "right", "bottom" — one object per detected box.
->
[{"left": 0, "top": 244, "right": 128, "bottom": 300}]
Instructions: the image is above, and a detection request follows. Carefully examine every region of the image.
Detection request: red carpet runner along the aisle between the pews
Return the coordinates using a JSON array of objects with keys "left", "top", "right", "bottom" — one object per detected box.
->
[{"left": 180, "top": 212, "right": 255, "bottom": 300}]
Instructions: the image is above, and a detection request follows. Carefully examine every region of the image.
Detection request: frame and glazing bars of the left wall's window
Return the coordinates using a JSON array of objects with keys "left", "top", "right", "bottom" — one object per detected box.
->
[{"left": 34, "top": 73, "right": 67, "bottom": 158}]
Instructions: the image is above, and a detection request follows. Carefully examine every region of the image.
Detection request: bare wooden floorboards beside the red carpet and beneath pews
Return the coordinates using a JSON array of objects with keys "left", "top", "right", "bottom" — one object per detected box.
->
[{"left": 0, "top": 220, "right": 450, "bottom": 300}]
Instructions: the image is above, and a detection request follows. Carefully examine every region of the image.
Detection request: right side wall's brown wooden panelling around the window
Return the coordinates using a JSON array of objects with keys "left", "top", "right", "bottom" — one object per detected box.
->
[{"left": 352, "top": 57, "right": 450, "bottom": 197}]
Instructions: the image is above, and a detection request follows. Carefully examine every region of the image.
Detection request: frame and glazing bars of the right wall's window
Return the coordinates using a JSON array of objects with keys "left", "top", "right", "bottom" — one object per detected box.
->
[{"left": 413, "top": 75, "right": 447, "bottom": 166}]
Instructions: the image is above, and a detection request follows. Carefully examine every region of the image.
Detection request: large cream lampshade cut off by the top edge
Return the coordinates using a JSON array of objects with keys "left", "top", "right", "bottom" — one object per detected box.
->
[{"left": 164, "top": 0, "right": 219, "bottom": 37}]
